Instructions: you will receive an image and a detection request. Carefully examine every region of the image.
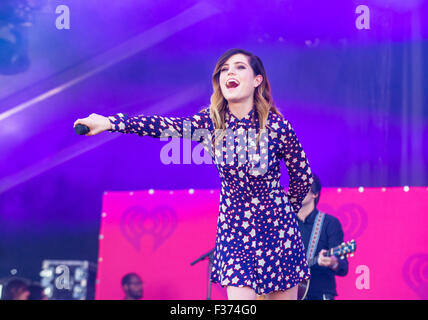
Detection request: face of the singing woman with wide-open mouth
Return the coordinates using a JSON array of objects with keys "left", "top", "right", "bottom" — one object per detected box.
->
[{"left": 219, "top": 53, "right": 263, "bottom": 103}]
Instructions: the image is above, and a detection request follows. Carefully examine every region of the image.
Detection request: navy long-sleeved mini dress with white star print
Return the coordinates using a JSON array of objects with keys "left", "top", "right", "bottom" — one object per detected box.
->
[{"left": 108, "top": 107, "right": 312, "bottom": 294}]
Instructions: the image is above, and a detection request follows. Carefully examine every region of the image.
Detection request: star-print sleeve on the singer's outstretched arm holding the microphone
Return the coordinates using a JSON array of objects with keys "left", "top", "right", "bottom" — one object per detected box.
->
[{"left": 107, "top": 108, "right": 210, "bottom": 142}]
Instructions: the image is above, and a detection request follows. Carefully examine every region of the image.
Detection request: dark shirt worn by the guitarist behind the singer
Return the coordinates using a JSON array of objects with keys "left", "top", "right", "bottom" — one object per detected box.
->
[{"left": 297, "top": 208, "right": 348, "bottom": 298}]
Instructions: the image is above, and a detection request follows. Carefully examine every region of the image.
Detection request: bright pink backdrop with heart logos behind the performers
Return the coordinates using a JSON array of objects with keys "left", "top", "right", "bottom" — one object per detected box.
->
[{"left": 96, "top": 187, "right": 428, "bottom": 300}]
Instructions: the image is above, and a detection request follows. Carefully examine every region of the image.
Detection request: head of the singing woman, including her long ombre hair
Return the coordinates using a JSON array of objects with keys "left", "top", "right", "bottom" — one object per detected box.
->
[{"left": 210, "top": 49, "right": 281, "bottom": 142}]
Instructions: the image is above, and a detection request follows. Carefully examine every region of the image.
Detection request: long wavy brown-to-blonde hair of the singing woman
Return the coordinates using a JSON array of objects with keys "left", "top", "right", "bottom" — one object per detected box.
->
[{"left": 210, "top": 49, "right": 282, "bottom": 142}]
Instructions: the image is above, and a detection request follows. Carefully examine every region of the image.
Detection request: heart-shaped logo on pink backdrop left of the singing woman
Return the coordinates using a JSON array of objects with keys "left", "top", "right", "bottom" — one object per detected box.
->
[{"left": 120, "top": 206, "right": 177, "bottom": 251}]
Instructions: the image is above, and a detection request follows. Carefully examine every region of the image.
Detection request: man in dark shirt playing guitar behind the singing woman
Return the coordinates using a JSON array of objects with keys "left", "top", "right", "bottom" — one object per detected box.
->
[{"left": 297, "top": 174, "right": 348, "bottom": 300}]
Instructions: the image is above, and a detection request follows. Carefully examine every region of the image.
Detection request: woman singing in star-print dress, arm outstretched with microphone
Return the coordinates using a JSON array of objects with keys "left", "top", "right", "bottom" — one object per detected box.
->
[{"left": 74, "top": 49, "right": 312, "bottom": 300}]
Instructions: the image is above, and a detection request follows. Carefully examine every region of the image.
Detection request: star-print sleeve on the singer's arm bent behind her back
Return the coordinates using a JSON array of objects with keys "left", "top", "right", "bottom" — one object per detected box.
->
[{"left": 280, "top": 119, "right": 313, "bottom": 213}]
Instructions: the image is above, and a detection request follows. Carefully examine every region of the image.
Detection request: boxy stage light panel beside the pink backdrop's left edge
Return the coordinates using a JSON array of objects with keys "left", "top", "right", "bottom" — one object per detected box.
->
[{"left": 40, "top": 260, "right": 96, "bottom": 300}]
